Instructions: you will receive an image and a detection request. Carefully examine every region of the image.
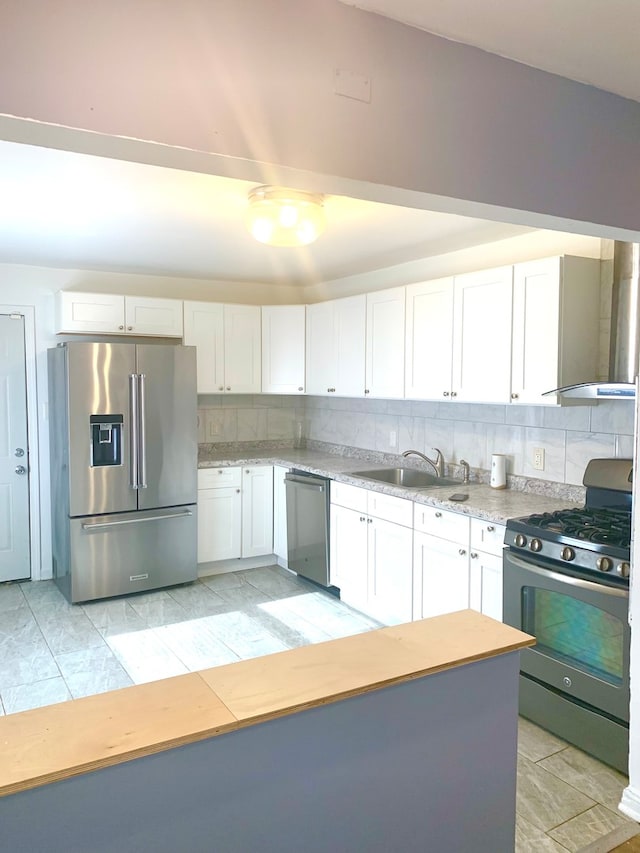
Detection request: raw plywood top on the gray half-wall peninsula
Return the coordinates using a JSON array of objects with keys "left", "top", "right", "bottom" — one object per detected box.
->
[{"left": 0, "top": 610, "right": 534, "bottom": 796}]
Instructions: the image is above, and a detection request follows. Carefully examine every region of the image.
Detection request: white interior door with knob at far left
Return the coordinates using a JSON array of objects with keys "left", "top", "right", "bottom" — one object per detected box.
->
[{"left": 0, "top": 314, "right": 31, "bottom": 581}]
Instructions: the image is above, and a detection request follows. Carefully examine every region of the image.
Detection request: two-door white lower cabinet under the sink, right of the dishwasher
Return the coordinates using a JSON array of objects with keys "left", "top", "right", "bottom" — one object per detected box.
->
[{"left": 330, "top": 483, "right": 413, "bottom": 624}]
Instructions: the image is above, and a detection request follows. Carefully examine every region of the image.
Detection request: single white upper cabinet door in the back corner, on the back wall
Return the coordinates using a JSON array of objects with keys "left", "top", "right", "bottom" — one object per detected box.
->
[{"left": 262, "top": 305, "right": 305, "bottom": 394}]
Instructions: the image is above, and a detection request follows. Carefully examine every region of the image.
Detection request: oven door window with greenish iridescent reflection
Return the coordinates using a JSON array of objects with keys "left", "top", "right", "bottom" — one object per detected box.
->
[{"left": 522, "top": 586, "right": 624, "bottom": 687}]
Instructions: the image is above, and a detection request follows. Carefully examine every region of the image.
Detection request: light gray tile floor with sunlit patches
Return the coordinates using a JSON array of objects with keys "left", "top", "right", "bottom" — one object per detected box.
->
[{"left": 0, "top": 566, "right": 640, "bottom": 853}]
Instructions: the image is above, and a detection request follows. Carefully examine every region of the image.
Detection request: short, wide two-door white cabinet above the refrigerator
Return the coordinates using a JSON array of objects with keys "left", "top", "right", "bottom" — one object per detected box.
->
[{"left": 56, "top": 290, "right": 182, "bottom": 338}]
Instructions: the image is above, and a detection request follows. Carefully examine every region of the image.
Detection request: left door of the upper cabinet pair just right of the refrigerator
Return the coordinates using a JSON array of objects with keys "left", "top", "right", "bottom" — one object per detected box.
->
[{"left": 183, "top": 302, "right": 224, "bottom": 394}]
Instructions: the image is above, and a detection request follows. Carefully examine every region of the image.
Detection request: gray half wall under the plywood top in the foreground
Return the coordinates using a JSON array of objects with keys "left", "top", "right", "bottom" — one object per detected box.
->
[{"left": 0, "top": 653, "right": 519, "bottom": 853}]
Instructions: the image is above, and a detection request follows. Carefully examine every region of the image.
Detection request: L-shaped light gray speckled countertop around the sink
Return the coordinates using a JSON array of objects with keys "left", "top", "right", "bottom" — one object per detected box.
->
[{"left": 198, "top": 445, "right": 582, "bottom": 524}]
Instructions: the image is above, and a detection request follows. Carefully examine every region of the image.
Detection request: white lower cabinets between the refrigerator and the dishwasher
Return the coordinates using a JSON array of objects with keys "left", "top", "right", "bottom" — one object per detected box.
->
[{"left": 198, "top": 465, "right": 273, "bottom": 563}]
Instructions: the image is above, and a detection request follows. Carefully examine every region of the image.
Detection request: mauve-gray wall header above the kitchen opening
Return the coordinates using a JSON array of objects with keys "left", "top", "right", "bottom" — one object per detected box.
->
[{"left": 0, "top": 0, "right": 640, "bottom": 233}]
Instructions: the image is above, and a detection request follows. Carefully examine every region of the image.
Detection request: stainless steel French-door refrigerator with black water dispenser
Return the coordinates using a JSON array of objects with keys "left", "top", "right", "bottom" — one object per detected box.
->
[{"left": 48, "top": 342, "right": 198, "bottom": 602}]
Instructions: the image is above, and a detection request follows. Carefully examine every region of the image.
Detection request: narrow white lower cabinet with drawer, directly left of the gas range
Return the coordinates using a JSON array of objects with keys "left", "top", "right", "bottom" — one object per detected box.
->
[{"left": 469, "top": 518, "right": 505, "bottom": 622}]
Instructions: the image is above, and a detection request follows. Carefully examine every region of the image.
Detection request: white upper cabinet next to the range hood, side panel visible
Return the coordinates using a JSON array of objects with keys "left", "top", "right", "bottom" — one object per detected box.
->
[{"left": 511, "top": 256, "right": 600, "bottom": 405}]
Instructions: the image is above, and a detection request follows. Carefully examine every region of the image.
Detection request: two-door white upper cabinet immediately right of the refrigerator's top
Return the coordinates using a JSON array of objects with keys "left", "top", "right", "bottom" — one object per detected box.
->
[{"left": 184, "top": 302, "right": 261, "bottom": 394}]
